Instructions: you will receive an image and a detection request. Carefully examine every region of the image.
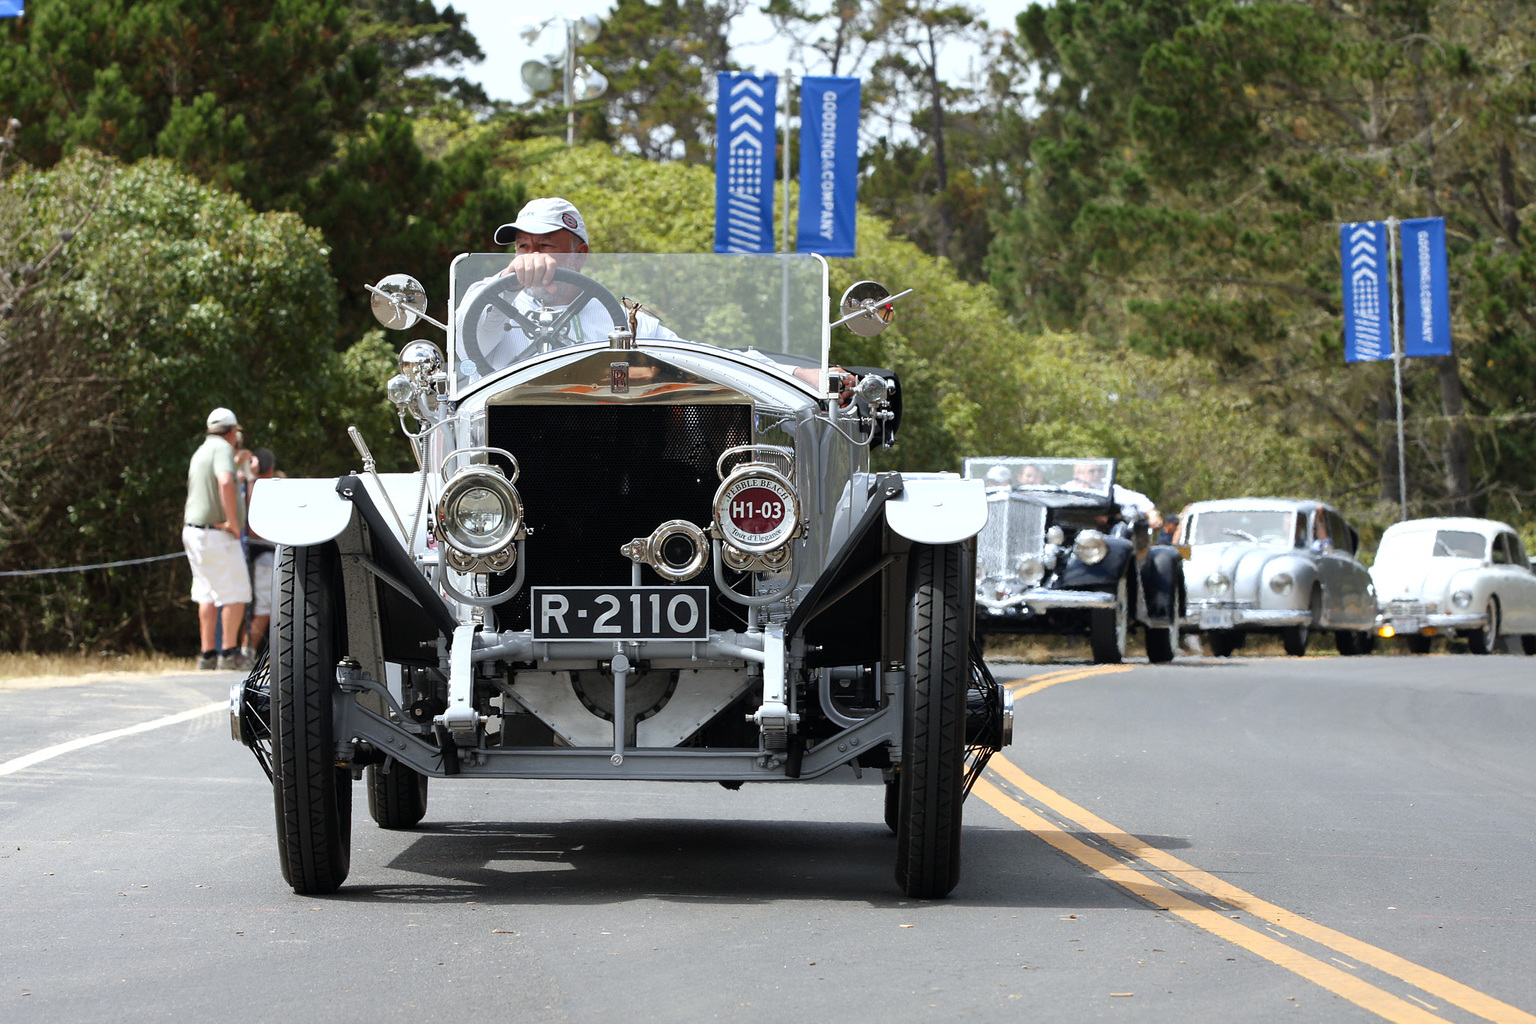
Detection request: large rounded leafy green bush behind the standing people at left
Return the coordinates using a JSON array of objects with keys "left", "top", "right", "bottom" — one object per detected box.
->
[{"left": 0, "top": 154, "right": 392, "bottom": 649}]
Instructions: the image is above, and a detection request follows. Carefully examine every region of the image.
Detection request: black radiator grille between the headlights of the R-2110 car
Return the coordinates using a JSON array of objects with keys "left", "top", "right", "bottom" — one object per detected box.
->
[{"left": 485, "top": 405, "right": 753, "bottom": 629}]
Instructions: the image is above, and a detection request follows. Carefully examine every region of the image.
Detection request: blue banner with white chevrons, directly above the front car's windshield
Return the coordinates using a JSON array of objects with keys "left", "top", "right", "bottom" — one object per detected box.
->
[{"left": 714, "top": 71, "right": 779, "bottom": 252}]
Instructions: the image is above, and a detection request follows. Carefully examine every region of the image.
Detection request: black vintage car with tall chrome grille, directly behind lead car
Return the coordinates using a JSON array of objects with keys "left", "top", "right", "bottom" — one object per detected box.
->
[{"left": 965, "top": 457, "right": 1184, "bottom": 663}]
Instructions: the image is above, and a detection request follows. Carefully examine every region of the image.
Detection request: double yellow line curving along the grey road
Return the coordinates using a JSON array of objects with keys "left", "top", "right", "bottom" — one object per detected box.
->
[{"left": 972, "top": 665, "right": 1536, "bottom": 1024}]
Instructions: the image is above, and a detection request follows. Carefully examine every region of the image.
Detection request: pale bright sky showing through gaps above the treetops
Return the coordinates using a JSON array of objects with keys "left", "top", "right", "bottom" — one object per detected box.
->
[{"left": 439, "top": 0, "right": 1028, "bottom": 101}]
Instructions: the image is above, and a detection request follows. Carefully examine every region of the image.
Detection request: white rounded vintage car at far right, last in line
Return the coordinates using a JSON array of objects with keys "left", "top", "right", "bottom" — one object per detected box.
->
[{"left": 1370, "top": 517, "right": 1536, "bottom": 654}]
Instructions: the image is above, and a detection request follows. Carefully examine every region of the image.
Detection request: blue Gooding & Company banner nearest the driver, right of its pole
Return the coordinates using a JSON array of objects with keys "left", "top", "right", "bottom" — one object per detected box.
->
[{"left": 794, "top": 75, "right": 859, "bottom": 256}]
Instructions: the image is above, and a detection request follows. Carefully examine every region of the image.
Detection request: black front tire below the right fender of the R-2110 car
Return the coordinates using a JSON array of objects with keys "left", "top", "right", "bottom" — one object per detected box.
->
[{"left": 895, "top": 543, "right": 974, "bottom": 900}]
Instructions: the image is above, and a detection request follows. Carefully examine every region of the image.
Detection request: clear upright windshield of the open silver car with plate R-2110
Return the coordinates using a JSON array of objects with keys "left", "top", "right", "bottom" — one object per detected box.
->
[{"left": 449, "top": 252, "right": 831, "bottom": 387}]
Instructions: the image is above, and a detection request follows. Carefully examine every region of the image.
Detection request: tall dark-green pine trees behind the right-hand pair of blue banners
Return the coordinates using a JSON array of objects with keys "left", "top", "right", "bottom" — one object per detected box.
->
[{"left": 991, "top": 0, "right": 1536, "bottom": 525}]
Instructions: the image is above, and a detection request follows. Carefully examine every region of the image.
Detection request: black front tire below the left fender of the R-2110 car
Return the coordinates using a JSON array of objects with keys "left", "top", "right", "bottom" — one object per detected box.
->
[{"left": 272, "top": 547, "right": 352, "bottom": 894}]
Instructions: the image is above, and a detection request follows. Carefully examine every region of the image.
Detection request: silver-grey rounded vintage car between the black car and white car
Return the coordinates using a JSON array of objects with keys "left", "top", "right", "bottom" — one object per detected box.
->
[{"left": 1175, "top": 497, "right": 1376, "bottom": 657}]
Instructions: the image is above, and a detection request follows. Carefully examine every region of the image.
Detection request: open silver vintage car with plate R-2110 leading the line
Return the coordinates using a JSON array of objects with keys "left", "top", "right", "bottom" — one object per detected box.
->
[{"left": 232, "top": 253, "right": 1011, "bottom": 897}]
